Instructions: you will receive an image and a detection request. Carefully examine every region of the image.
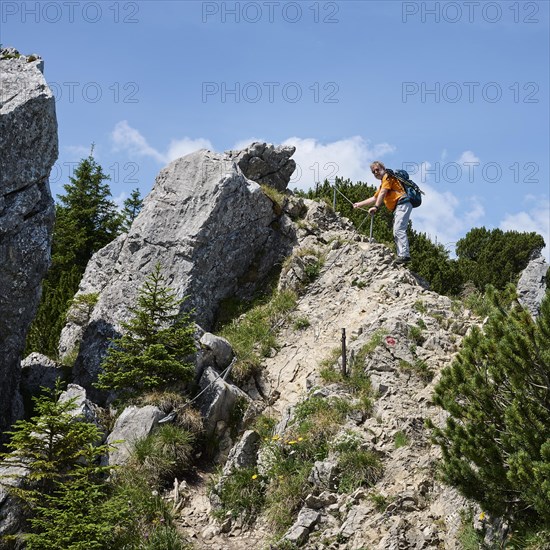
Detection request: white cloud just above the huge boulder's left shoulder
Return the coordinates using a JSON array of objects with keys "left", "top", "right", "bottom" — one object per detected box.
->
[{"left": 111, "top": 120, "right": 213, "bottom": 164}]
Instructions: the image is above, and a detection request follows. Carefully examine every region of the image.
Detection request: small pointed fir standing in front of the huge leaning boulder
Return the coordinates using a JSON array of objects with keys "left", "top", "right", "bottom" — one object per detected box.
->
[{"left": 97, "top": 263, "right": 195, "bottom": 395}]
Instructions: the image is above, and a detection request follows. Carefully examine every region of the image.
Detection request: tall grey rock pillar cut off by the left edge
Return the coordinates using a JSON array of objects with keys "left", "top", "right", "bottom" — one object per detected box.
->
[{"left": 0, "top": 48, "right": 58, "bottom": 436}]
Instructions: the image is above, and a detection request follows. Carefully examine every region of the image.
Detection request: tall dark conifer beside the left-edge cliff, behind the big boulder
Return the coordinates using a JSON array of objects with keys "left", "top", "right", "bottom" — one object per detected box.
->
[{"left": 25, "top": 147, "right": 122, "bottom": 358}]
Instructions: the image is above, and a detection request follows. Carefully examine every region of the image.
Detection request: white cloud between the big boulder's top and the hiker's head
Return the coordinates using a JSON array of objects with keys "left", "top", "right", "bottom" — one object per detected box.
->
[{"left": 283, "top": 136, "right": 395, "bottom": 190}]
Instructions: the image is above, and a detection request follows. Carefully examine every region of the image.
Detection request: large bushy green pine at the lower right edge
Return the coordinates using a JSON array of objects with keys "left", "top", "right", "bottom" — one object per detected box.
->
[{"left": 434, "top": 287, "right": 550, "bottom": 527}]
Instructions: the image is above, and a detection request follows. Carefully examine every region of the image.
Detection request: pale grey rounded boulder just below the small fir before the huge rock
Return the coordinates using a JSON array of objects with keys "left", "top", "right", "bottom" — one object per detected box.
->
[{"left": 104, "top": 405, "right": 165, "bottom": 466}]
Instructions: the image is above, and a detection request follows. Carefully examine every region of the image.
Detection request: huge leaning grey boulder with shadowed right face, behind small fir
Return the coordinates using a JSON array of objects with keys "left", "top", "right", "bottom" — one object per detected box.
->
[{"left": 60, "top": 144, "right": 295, "bottom": 397}]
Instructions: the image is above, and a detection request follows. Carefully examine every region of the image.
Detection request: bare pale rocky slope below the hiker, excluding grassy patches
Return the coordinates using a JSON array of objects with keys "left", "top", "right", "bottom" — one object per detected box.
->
[{"left": 175, "top": 199, "right": 486, "bottom": 550}]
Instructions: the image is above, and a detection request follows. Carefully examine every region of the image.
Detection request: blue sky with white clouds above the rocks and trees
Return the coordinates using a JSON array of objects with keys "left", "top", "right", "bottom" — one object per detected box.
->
[{"left": 0, "top": 0, "right": 550, "bottom": 256}]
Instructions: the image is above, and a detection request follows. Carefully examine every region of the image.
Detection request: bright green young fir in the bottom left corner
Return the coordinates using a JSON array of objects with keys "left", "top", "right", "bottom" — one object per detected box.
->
[{"left": 0, "top": 383, "right": 134, "bottom": 550}]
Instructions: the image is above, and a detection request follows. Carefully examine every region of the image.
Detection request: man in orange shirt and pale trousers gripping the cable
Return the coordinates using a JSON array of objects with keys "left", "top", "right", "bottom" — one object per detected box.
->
[{"left": 353, "top": 160, "right": 413, "bottom": 264}]
